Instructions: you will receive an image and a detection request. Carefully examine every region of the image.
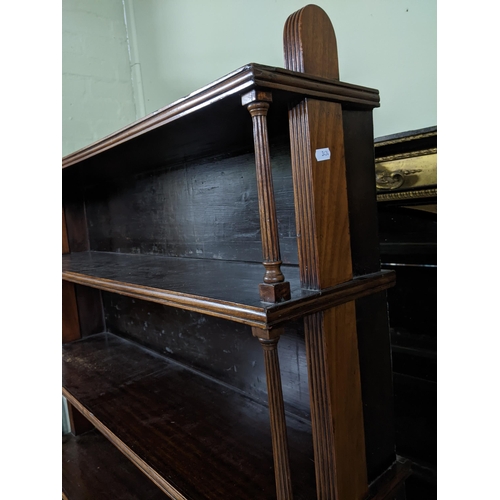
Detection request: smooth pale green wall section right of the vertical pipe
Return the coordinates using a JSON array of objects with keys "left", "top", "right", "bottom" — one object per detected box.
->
[{"left": 130, "top": 0, "right": 437, "bottom": 137}]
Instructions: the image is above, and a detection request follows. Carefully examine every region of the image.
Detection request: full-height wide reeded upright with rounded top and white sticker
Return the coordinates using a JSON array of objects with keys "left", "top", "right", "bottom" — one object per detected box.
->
[{"left": 284, "top": 5, "right": 368, "bottom": 500}]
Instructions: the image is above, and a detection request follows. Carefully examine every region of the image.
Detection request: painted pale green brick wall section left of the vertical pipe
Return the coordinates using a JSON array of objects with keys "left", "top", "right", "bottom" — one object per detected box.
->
[{"left": 62, "top": 0, "right": 136, "bottom": 155}]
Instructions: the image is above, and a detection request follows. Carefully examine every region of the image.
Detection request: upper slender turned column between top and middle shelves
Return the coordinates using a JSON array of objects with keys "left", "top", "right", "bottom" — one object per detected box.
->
[{"left": 241, "top": 90, "right": 290, "bottom": 303}]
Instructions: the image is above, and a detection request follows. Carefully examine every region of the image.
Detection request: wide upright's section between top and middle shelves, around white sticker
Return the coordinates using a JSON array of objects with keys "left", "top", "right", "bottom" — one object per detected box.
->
[{"left": 290, "top": 100, "right": 352, "bottom": 289}]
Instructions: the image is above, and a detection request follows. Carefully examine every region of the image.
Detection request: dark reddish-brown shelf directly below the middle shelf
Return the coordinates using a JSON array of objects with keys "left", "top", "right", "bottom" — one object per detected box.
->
[{"left": 63, "top": 333, "right": 316, "bottom": 500}]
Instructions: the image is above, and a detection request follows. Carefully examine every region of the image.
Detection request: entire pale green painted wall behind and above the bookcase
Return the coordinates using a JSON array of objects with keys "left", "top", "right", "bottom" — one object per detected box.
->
[{"left": 63, "top": 0, "right": 437, "bottom": 148}]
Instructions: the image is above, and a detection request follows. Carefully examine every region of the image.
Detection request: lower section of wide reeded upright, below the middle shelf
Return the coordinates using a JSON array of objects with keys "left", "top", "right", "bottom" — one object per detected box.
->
[{"left": 304, "top": 302, "right": 368, "bottom": 499}]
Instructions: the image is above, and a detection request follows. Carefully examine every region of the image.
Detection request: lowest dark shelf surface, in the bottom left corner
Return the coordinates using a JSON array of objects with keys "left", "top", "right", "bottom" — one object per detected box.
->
[{"left": 62, "top": 430, "right": 167, "bottom": 500}]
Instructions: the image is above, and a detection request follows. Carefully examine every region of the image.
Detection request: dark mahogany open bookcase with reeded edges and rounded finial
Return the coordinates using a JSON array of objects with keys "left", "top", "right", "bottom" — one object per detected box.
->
[{"left": 62, "top": 5, "right": 409, "bottom": 500}]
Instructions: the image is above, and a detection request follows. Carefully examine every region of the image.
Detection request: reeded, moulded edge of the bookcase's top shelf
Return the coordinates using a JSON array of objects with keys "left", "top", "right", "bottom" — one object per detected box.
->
[{"left": 62, "top": 63, "right": 379, "bottom": 172}]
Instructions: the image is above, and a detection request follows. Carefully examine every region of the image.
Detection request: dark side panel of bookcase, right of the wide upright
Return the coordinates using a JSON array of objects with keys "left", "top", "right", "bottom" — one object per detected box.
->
[{"left": 343, "top": 110, "right": 396, "bottom": 481}]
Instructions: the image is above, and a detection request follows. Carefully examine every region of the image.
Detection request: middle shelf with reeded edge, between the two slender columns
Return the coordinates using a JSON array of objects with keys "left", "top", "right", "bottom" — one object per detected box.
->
[{"left": 62, "top": 252, "right": 395, "bottom": 329}]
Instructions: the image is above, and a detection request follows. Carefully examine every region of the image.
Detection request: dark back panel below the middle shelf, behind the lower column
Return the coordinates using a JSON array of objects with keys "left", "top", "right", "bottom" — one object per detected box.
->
[{"left": 102, "top": 292, "right": 309, "bottom": 418}]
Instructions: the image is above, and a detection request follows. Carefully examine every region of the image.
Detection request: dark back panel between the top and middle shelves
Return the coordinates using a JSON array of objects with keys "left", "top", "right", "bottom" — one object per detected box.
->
[{"left": 85, "top": 143, "right": 297, "bottom": 264}]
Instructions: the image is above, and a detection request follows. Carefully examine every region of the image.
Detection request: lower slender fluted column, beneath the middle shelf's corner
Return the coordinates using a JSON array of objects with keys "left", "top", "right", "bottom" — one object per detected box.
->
[{"left": 252, "top": 327, "right": 293, "bottom": 500}]
